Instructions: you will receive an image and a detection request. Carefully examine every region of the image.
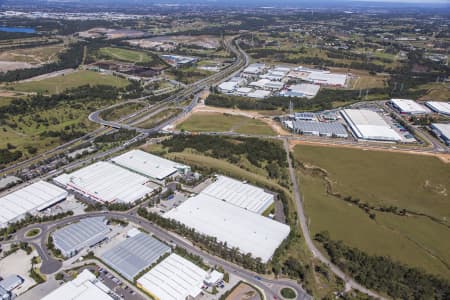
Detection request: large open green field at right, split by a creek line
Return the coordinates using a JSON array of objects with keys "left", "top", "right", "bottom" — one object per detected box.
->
[{"left": 295, "top": 146, "right": 450, "bottom": 278}]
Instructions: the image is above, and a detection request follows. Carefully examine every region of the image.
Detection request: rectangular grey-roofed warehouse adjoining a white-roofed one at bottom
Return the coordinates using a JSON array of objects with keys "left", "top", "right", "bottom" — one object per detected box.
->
[{"left": 101, "top": 232, "right": 171, "bottom": 281}]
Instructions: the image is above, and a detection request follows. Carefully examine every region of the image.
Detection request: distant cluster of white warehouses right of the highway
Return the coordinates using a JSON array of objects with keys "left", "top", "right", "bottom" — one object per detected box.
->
[{"left": 217, "top": 63, "right": 348, "bottom": 98}]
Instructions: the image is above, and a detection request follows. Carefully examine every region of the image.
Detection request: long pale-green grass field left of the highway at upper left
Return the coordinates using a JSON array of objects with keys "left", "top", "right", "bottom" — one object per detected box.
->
[{"left": 8, "top": 70, "right": 128, "bottom": 94}]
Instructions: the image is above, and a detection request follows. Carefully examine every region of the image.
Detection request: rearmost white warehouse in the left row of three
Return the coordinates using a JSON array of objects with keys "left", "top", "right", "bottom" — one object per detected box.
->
[{"left": 111, "top": 150, "right": 191, "bottom": 182}]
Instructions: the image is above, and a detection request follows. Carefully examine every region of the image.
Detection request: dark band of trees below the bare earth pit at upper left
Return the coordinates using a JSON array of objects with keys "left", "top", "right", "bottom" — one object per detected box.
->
[{"left": 0, "top": 43, "right": 84, "bottom": 82}]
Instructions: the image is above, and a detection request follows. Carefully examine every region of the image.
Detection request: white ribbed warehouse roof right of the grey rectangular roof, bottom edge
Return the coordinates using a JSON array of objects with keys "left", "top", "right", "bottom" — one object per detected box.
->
[{"left": 137, "top": 254, "right": 208, "bottom": 300}]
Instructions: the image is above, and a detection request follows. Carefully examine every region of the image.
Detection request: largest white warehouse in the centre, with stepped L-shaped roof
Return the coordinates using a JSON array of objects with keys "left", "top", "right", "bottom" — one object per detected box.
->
[{"left": 163, "top": 176, "right": 290, "bottom": 262}]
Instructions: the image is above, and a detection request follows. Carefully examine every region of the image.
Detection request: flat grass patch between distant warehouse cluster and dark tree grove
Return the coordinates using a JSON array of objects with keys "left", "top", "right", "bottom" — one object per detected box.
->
[{"left": 177, "top": 113, "right": 275, "bottom": 135}]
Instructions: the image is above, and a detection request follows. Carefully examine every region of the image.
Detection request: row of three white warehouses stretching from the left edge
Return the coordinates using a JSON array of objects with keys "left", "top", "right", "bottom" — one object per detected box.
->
[{"left": 0, "top": 150, "right": 190, "bottom": 228}]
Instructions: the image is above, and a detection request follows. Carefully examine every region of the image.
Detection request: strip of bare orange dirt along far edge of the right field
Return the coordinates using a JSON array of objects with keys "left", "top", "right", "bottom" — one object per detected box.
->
[{"left": 289, "top": 140, "right": 450, "bottom": 164}]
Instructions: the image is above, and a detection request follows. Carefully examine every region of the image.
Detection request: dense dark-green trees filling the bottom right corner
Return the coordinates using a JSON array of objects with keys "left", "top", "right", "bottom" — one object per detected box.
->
[{"left": 315, "top": 232, "right": 450, "bottom": 299}]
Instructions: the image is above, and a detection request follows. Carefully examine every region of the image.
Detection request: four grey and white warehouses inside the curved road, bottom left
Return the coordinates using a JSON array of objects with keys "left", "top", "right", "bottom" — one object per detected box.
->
[{"left": 50, "top": 217, "right": 223, "bottom": 300}]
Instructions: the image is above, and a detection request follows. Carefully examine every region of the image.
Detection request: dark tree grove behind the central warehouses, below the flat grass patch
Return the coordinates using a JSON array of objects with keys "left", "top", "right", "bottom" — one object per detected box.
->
[{"left": 162, "top": 135, "right": 287, "bottom": 172}]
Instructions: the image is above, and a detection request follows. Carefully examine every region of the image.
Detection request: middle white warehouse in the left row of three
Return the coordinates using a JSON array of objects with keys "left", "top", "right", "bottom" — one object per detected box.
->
[{"left": 54, "top": 161, "right": 153, "bottom": 203}]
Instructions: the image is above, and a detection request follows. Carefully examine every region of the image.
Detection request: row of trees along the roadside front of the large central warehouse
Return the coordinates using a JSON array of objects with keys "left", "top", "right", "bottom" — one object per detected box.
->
[{"left": 138, "top": 207, "right": 266, "bottom": 274}]
